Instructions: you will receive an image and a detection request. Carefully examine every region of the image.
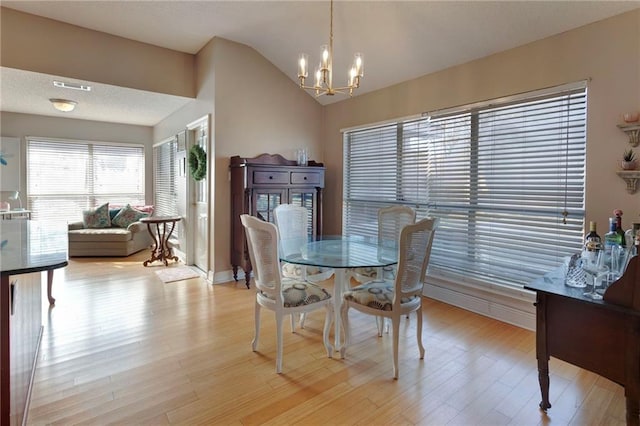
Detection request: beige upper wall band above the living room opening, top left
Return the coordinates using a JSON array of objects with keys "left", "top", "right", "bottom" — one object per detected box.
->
[{"left": 0, "top": 7, "right": 195, "bottom": 98}]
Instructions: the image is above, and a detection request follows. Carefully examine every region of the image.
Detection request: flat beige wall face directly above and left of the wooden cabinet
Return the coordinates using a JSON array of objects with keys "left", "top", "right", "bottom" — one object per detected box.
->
[{"left": 208, "top": 39, "right": 323, "bottom": 272}]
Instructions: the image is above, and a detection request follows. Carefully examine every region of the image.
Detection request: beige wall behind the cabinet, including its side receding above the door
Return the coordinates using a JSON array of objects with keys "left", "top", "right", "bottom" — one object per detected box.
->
[{"left": 154, "top": 38, "right": 323, "bottom": 273}]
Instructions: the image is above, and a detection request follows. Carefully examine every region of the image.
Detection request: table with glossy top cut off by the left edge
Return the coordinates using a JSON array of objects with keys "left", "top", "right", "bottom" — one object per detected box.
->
[{"left": 0, "top": 220, "right": 68, "bottom": 426}]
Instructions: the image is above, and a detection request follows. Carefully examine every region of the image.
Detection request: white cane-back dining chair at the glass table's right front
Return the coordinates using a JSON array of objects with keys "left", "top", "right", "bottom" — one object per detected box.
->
[{"left": 340, "top": 218, "right": 437, "bottom": 379}]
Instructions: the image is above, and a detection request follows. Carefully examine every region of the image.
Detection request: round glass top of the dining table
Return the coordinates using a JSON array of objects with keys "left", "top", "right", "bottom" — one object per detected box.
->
[{"left": 279, "top": 235, "right": 398, "bottom": 268}]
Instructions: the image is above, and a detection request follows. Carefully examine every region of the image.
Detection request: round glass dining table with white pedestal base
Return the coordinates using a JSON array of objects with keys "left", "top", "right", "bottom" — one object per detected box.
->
[{"left": 279, "top": 235, "right": 398, "bottom": 350}]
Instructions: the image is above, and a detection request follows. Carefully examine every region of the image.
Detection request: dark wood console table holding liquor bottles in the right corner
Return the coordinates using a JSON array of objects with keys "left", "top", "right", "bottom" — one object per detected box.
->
[{"left": 525, "top": 256, "right": 640, "bottom": 425}]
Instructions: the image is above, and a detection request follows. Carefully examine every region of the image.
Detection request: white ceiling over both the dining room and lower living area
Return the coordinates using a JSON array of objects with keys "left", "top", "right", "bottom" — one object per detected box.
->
[{"left": 0, "top": 0, "right": 640, "bottom": 126}]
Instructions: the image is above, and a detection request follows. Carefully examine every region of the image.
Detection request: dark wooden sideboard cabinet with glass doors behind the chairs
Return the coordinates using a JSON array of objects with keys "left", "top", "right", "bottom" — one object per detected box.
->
[{"left": 229, "top": 154, "right": 325, "bottom": 288}]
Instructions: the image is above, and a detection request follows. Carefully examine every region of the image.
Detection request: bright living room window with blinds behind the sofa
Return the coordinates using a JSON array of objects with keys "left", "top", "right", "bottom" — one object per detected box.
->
[{"left": 27, "top": 138, "right": 145, "bottom": 222}]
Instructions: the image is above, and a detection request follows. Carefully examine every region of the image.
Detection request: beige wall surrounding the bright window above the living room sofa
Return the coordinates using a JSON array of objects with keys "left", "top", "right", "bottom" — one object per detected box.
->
[{"left": 0, "top": 112, "right": 153, "bottom": 204}]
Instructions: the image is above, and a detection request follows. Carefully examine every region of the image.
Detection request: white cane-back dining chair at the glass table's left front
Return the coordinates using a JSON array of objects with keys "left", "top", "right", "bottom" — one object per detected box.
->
[{"left": 240, "top": 214, "right": 333, "bottom": 373}]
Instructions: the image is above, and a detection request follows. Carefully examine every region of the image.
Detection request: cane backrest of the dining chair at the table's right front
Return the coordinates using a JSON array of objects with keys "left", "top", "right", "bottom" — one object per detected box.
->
[{"left": 393, "top": 218, "right": 438, "bottom": 309}]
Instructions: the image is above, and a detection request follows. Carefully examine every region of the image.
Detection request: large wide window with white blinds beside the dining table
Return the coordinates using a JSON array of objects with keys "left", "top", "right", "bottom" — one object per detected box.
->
[{"left": 343, "top": 84, "right": 587, "bottom": 286}]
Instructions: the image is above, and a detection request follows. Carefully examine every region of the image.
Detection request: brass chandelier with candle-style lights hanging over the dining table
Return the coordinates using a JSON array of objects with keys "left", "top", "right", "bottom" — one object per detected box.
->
[{"left": 298, "top": 0, "right": 364, "bottom": 97}]
